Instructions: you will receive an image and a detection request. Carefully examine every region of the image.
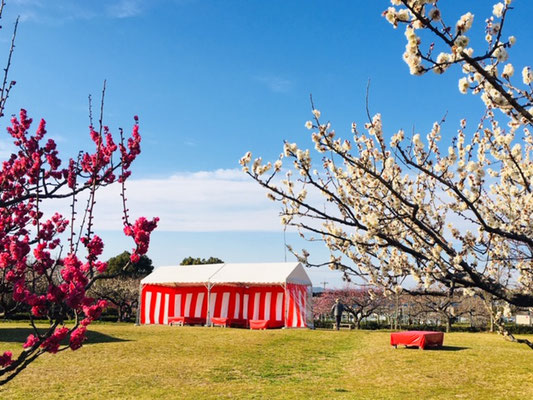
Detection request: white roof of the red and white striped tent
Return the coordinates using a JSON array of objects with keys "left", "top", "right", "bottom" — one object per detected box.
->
[{"left": 141, "top": 262, "right": 311, "bottom": 286}]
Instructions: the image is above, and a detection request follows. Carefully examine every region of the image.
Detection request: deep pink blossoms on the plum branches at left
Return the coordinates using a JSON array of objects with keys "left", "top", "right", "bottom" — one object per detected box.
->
[{"left": 0, "top": 109, "right": 157, "bottom": 367}]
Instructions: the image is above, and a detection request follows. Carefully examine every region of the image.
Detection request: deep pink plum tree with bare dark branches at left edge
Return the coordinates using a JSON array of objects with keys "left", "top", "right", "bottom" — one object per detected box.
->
[{"left": 0, "top": 1, "right": 158, "bottom": 385}]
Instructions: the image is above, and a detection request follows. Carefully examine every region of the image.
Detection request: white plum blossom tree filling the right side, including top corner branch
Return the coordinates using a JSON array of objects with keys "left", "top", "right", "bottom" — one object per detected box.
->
[{"left": 240, "top": 0, "right": 533, "bottom": 341}]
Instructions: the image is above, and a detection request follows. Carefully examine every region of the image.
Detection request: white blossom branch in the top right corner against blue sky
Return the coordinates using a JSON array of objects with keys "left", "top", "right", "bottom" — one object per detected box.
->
[{"left": 383, "top": 0, "right": 533, "bottom": 123}]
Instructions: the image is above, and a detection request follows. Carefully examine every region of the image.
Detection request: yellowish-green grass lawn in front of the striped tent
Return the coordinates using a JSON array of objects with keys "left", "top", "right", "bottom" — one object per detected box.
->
[{"left": 0, "top": 323, "right": 533, "bottom": 400}]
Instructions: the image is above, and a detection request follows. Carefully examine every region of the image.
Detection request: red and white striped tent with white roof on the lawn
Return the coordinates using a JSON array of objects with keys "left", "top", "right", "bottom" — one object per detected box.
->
[{"left": 140, "top": 262, "right": 313, "bottom": 328}]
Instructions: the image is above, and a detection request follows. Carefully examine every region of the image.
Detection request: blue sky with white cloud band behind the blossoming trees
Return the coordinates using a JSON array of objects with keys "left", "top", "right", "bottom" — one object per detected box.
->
[{"left": 0, "top": 0, "right": 533, "bottom": 286}]
